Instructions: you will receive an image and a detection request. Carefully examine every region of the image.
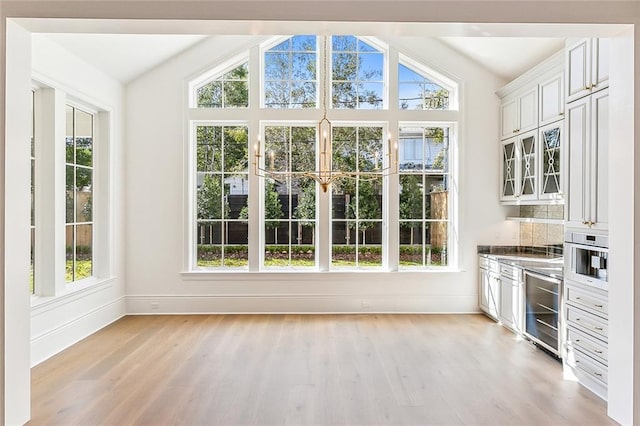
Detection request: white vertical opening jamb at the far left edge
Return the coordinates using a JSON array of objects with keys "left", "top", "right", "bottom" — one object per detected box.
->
[{"left": 2, "top": 22, "right": 31, "bottom": 425}]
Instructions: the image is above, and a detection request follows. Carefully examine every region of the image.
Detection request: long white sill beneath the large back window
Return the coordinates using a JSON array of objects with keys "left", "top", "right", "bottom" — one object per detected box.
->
[{"left": 180, "top": 267, "right": 463, "bottom": 281}]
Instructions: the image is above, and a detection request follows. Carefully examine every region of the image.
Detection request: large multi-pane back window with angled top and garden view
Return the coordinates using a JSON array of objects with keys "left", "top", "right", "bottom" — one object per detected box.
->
[{"left": 185, "top": 35, "right": 460, "bottom": 273}]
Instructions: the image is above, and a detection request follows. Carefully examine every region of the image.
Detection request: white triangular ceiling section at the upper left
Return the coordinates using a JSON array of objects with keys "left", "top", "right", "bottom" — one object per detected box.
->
[{"left": 47, "top": 34, "right": 207, "bottom": 84}]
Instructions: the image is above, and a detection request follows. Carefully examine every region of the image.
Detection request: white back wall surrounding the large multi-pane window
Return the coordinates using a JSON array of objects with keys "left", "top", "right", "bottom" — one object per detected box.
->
[{"left": 126, "top": 30, "right": 518, "bottom": 313}]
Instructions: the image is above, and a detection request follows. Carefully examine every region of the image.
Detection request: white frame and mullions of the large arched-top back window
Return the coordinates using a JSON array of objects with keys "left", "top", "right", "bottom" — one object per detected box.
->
[{"left": 181, "top": 35, "right": 462, "bottom": 281}]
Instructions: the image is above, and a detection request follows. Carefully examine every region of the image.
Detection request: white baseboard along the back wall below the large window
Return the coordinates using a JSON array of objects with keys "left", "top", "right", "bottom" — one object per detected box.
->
[{"left": 126, "top": 294, "right": 479, "bottom": 315}]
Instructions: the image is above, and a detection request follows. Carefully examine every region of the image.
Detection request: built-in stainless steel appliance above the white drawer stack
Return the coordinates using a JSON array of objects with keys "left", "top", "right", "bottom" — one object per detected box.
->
[{"left": 564, "top": 232, "right": 609, "bottom": 290}]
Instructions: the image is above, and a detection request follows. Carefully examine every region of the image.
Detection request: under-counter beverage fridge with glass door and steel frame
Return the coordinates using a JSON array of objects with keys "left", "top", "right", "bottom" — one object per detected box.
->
[{"left": 524, "top": 270, "right": 562, "bottom": 356}]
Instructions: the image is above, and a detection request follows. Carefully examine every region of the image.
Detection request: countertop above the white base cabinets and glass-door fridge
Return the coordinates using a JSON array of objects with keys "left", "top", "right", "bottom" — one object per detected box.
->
[{"left": 478, "top": 246, "right": 564, "bottom": 279}]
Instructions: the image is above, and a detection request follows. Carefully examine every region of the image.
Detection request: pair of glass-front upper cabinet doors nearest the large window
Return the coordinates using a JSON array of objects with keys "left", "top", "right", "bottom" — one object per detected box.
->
[{"left": 500, "top": 130, "right": 540, "bottom": 202}]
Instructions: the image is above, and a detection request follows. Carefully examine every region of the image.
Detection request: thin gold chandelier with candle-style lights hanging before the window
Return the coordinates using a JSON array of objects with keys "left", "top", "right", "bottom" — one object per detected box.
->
[{"left": 253, "top": 36, "right": 398, "bottom": 192}]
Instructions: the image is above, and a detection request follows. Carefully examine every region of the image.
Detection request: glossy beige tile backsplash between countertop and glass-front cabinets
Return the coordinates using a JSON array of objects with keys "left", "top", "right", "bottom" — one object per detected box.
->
[{"left": 520, "top": 205, "right": 564, "bottom": 246}]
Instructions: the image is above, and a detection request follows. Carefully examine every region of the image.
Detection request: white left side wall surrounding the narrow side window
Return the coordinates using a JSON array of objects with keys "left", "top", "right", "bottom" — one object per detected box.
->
[{"left": 25, "top": 34, "right": 125, "bottom": 365}]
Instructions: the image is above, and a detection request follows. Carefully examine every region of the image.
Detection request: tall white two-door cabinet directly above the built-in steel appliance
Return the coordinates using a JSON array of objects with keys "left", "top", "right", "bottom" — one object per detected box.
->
[{"left": 565, "top": 90, "right": 609, "bottom": 231}]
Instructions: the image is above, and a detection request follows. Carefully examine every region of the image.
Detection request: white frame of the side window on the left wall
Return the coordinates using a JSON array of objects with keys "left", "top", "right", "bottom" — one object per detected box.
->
[{"left": 31, "top": 75, "right": 115, "bottom": 306}]
